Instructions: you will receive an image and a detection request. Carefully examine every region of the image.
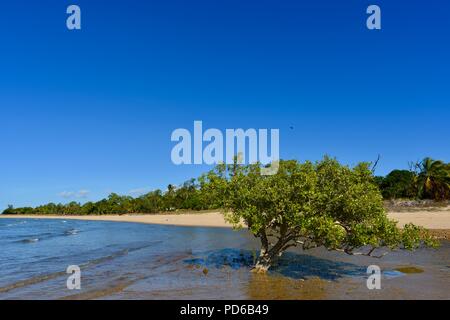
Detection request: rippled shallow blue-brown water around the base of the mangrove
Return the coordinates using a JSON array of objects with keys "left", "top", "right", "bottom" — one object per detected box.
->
[{"left": 0, "top": 219, "right": 450, "bottom": 299}]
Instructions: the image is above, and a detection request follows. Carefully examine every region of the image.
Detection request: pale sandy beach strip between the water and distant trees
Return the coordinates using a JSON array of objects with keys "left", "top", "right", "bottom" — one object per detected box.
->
[{"left": 0, "top": 210, "right": 450, "bottom": 240}]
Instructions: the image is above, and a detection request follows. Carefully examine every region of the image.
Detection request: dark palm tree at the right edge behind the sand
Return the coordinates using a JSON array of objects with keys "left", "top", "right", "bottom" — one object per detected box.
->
[{"left": 417, "top": 157, "right": 450, "bottom": 200}]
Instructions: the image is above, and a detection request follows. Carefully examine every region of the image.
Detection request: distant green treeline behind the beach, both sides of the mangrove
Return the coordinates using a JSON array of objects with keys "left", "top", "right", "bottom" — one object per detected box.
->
[{"left": 3, "top": 158, "right": 450, "bottom": 215}]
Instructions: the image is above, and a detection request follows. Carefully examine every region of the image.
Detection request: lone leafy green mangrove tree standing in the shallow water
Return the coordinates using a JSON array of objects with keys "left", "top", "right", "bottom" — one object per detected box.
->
[{"left": 202, "top": 157, "right": 438, "bottom": 270}]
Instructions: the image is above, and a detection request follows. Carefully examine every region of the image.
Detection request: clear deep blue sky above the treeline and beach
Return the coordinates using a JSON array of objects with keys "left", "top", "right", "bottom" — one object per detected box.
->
[{"left": 0, "top": 0, "right": 450, "bottom": 208}]
